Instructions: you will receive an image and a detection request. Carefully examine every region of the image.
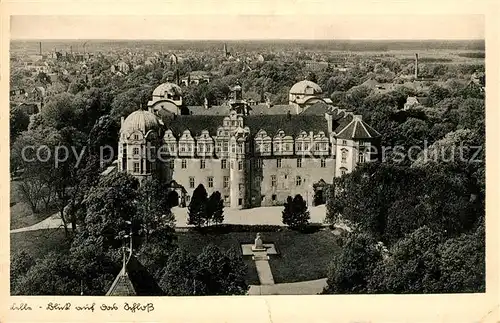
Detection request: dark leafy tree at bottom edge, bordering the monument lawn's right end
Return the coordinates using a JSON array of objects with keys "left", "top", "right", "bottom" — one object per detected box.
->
[{"left": 323, "top": 233, "right": 381, "bottom": 294}]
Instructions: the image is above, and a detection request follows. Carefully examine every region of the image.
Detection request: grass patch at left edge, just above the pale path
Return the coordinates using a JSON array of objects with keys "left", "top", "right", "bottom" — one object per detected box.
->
[{"left": 10, "top": 181, "right": 57, "bottom": 230}]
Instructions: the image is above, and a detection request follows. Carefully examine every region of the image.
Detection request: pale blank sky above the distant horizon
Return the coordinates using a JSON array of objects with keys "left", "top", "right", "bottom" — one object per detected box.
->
[{"left": 10, "top": 14, "right": 485, "bottom": 40}]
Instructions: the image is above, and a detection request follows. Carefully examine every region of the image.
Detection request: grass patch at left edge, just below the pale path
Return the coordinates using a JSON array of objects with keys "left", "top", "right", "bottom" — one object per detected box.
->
[{"left": 10, "top": 229, "right": 70, "bottom": 259}]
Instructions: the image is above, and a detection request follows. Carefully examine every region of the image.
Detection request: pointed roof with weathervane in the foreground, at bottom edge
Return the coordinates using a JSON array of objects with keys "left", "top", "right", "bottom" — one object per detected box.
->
[{"left": 106, "top": 255, "right": 164, "bottom": 296}]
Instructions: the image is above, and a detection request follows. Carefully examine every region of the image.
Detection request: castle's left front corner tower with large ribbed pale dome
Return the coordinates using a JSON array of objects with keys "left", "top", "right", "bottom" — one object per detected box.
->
[{"left": 118, "top": 110, "right": 161, "bottom": 181}]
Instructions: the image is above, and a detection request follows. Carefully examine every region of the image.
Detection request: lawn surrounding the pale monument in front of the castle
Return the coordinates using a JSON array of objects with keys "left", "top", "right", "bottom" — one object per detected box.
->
[{"left": 177, "top": 230, "right": 339, "bottom": 284}]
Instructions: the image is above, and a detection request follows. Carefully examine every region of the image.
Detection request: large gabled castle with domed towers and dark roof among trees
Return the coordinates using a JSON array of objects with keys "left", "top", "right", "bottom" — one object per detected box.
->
[{"left": 117, "top": 81, "right": 380, "bottom": 208}]
